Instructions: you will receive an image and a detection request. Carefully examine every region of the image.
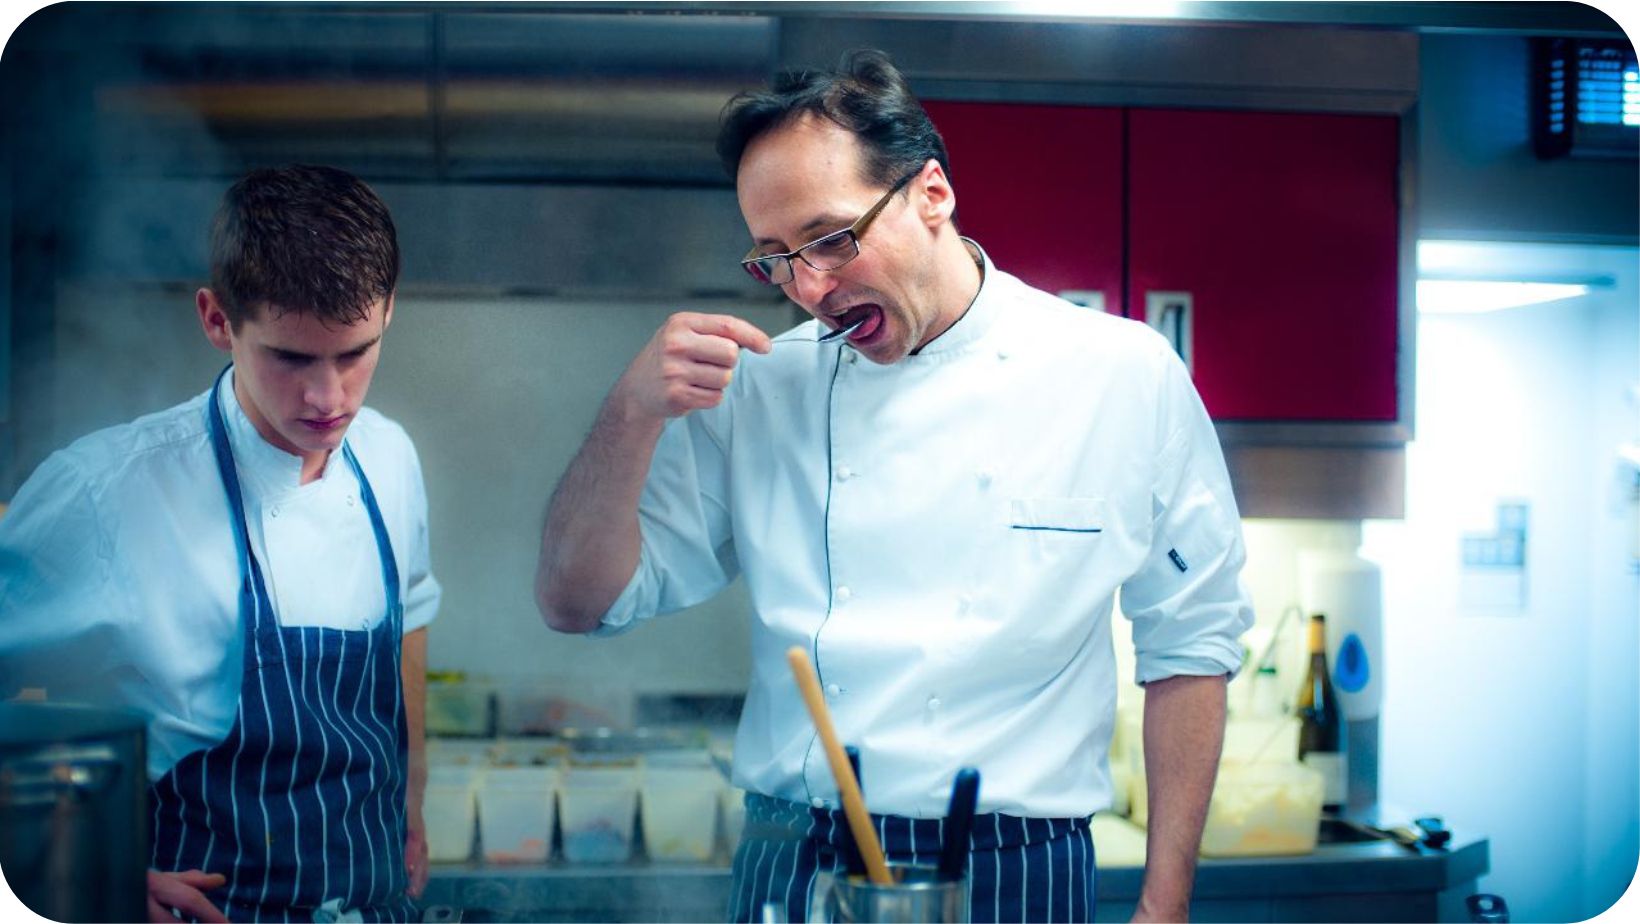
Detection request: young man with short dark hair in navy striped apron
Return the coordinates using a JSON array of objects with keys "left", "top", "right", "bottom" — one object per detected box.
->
[{"left": 0, "top": 166, "right": 440, "bottom": 921}]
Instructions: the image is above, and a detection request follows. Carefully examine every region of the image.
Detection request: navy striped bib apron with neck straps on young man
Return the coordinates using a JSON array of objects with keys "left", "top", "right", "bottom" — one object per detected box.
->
[{"left": 151, "top": 371, "right": 415, "bottom": 921}]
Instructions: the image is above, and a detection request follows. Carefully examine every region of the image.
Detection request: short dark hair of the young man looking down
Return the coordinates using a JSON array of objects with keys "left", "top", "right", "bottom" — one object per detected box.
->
[{"left": 210, "top": 164, "right": 399, "bottom": 330}]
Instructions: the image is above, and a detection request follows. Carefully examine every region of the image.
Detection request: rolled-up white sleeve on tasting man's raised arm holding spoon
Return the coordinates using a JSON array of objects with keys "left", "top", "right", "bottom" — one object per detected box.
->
[{"left": 592, "top": 412, "right": 740, "bottom": 635}]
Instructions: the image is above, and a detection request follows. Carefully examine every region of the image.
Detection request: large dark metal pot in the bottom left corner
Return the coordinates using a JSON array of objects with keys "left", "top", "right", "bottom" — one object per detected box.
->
[{"left": 0, "top": 702, "right": 151, "bottom": 921}]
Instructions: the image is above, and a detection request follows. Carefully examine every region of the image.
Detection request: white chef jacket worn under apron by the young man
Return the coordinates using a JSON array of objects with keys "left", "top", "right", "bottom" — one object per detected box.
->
[{"left": 0, "top": 373, "right": 441, "bottom": 780}]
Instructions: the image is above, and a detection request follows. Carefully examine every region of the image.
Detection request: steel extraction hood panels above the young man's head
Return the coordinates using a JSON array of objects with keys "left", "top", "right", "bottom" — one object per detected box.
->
[{"left": 13, "top": 5, "right": 776, "bottom": 185}]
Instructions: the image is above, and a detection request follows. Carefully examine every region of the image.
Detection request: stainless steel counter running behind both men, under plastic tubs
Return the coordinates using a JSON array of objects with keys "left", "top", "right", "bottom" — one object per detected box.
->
[{"left": 423, "top": 839, "right": 1489, "bottom": 922}]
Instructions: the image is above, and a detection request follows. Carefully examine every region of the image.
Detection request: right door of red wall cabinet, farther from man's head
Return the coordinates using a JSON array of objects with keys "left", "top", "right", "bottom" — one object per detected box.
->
[{"left": 1127, "top": 110, "right": 1401, "bottom": 422}]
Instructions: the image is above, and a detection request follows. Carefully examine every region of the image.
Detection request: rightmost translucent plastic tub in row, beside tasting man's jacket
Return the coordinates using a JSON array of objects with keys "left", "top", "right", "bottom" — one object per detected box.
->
[{"left": 638, "top": 750, "right": 723, "bottom": 863}]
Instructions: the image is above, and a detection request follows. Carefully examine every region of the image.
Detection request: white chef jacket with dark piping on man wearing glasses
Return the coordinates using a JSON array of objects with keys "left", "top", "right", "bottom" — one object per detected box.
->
[{"left": 599, "top": 245, "right": 1253, "bottom": 817}]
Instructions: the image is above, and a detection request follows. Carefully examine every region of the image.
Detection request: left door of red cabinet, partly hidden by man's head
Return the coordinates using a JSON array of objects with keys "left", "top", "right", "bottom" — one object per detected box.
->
[{"left": 923, "top": 102, "right": 1123, "bottom": 312}]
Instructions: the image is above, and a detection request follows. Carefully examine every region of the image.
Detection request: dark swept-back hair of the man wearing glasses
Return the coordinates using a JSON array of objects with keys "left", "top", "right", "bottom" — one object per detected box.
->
[{"left": 717, "top": 49, "right": 951, "bottom": 185}]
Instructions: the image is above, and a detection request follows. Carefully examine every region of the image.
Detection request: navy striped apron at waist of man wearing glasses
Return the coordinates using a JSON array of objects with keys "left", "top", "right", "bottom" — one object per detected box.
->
[{"left": 728, "top": 793, "right": 1094, "bottom": 922}]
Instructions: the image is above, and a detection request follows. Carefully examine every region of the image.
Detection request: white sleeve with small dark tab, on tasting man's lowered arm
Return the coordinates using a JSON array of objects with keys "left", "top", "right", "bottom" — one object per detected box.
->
[{"left": 1120, "top": 355, "right": 1253, "bottom": 684}]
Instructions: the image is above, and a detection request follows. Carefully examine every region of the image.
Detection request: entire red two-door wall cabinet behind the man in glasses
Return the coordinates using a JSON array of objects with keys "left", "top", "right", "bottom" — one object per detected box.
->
[{"left": 928, "top": 102, "right": 1401, "bottom": 422}]
